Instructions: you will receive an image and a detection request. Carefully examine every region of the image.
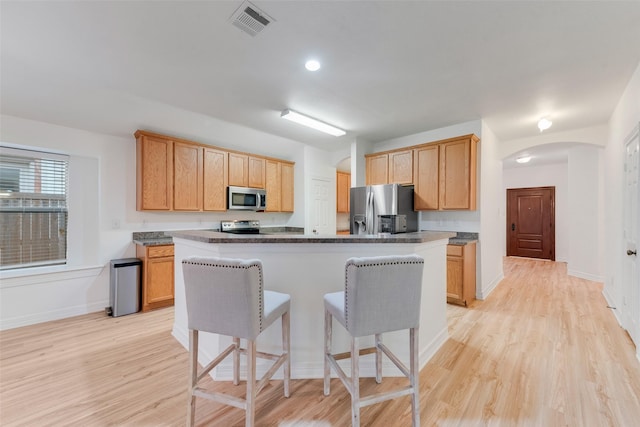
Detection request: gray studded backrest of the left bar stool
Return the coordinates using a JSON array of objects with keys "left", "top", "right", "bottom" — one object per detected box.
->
[{"left": 182, "top": 257, "right": 264, "bottom": 339}]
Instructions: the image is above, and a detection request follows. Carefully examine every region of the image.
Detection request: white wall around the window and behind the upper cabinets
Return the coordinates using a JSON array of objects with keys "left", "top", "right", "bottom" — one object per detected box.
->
[{"left": 0, "top": 112, "right": 318, "bottom": 329}]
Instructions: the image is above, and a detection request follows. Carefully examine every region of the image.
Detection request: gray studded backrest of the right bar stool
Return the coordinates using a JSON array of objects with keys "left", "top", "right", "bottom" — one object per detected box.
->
[{"left": 345, "top": 254, "right": 424, "bottom": 337}]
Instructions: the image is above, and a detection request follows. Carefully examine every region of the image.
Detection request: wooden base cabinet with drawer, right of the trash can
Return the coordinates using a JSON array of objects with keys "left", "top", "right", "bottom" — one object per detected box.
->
[{"left": 136, "top": 245, "right": 174, "bottom": 311}]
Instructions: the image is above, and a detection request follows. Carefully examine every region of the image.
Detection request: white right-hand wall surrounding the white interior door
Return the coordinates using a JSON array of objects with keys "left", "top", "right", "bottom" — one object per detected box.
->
[{"left": 603, "top": 61, "right": 640, "bottom": 348}]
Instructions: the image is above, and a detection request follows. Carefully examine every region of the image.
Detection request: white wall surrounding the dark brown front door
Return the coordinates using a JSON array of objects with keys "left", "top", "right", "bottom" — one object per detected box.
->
[{"left": 503, "top": 162, "right": 569, "bottom": 262}]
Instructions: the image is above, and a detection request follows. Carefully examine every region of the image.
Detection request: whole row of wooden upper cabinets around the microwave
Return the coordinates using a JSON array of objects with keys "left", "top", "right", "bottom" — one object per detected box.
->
[{"left": 135, "top": 130, "right": 294, "bottom": 212}]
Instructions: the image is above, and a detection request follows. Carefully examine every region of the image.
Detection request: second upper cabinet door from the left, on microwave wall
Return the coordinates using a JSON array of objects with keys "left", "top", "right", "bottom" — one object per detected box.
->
[{"left": 173, "top": 142, "right": 203, "bottom": 211}]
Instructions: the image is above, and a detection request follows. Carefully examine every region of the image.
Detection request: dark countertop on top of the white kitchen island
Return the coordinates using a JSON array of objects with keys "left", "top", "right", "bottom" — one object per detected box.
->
[{"left": 165, "top": 230, "right": 455, "bottom": 243}]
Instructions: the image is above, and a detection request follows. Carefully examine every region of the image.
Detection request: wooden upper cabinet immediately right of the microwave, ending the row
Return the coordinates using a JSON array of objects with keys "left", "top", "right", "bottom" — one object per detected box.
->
[{"left": 265, "top": 159, "right": 293, "bottom": 212}]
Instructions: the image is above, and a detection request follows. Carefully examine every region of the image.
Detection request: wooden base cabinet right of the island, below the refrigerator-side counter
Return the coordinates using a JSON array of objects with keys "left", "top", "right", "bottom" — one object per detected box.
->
[{"left": 447, "top": 242, "right": 476, "bottom": 306}]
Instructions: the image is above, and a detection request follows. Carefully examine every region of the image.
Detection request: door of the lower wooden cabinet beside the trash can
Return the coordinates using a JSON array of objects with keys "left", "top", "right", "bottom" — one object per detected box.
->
[{"left": 142, "top": 257, "right": 174, "bottom": 311}]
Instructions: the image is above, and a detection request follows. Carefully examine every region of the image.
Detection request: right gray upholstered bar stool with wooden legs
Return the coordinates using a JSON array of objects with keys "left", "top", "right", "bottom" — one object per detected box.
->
[{"left": 324, "top": 255, "right": 424, "bottom": 427}]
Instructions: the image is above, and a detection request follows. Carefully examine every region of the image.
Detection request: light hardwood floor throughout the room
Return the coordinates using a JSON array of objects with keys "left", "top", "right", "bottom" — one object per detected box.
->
[{"left": 0, "top": 258, "right": 640, "bottom": 427}]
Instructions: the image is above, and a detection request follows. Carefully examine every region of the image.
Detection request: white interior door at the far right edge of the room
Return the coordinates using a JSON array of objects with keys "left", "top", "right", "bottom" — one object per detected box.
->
[{"left": 622, "top": 125, "right": 640, "bottom": 354}]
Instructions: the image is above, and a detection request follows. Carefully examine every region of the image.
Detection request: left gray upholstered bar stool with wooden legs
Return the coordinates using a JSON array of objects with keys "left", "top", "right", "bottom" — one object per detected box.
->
[{"left": 182, "top": 257, "right": 291, "bottom": 427}]
